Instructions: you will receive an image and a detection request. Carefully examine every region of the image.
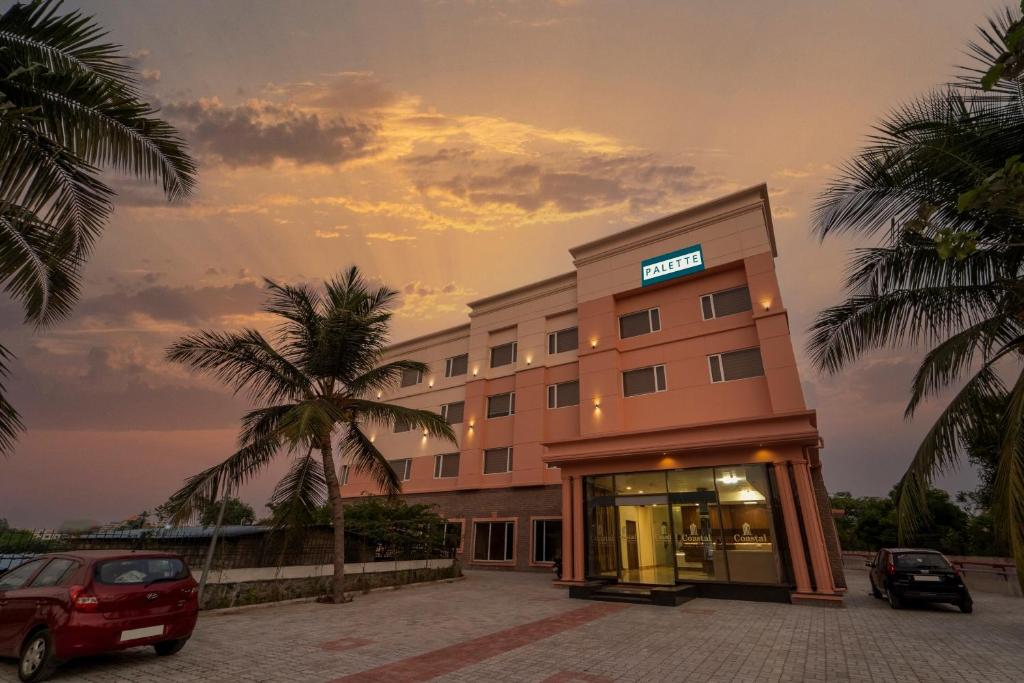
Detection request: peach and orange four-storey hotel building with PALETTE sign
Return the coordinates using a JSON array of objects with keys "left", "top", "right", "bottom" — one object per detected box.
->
[{"left": 343, "top": 185, "right": 845, "bottom": 603}]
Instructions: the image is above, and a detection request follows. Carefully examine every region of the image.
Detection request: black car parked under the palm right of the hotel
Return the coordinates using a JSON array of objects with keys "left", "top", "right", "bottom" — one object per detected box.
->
[{"left": 864, "top": 548, "right": 974, "bottom": 613}]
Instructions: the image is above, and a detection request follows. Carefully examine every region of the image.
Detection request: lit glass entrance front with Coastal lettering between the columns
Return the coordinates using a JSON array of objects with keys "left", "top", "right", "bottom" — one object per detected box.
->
[{"left": 586, "top": 465, "right": 780, "bottom": 585}]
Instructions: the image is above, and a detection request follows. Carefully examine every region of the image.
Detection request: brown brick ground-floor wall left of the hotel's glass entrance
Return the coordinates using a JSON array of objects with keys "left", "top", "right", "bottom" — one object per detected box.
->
[{"left": 403, "top": 486, "right": 562, "bottom": 570}]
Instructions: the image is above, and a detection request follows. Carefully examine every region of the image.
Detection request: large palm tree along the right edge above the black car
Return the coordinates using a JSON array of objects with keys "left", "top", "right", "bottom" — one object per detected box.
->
[{"left": 809, "top": 5, "right": 1024, "bottom": 585}]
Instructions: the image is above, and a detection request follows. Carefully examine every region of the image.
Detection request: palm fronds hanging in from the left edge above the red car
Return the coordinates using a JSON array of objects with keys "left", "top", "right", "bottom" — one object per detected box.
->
[{"left": 0, "top": 0, "right": 196, "bottom": 455}]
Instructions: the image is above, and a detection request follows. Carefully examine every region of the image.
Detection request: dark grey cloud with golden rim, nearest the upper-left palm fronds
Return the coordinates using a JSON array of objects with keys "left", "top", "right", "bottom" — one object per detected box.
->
[{"left": 164, "top": 98, "right": 377, "bottom": 167}]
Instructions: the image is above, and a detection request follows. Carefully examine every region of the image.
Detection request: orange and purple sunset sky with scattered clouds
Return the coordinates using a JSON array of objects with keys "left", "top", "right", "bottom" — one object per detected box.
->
[{"left": 0, "top": 0, "right": 1004, "bottom": 526}]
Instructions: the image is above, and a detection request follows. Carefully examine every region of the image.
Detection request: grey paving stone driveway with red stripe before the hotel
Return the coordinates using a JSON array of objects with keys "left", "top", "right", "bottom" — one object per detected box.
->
[{"left": 0, "top": 571, "right": 1024, "bottom": 683}]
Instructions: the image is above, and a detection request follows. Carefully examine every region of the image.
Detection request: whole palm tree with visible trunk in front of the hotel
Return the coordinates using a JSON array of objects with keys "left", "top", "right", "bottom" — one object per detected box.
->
[{"left": 166, "top": 266, "right": 455, "bottom": 602}]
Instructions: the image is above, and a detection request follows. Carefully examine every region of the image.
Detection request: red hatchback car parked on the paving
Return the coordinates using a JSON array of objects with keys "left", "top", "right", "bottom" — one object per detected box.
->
[{"left": 0, "top": 550, "right": 199, "bottom": 681}]
